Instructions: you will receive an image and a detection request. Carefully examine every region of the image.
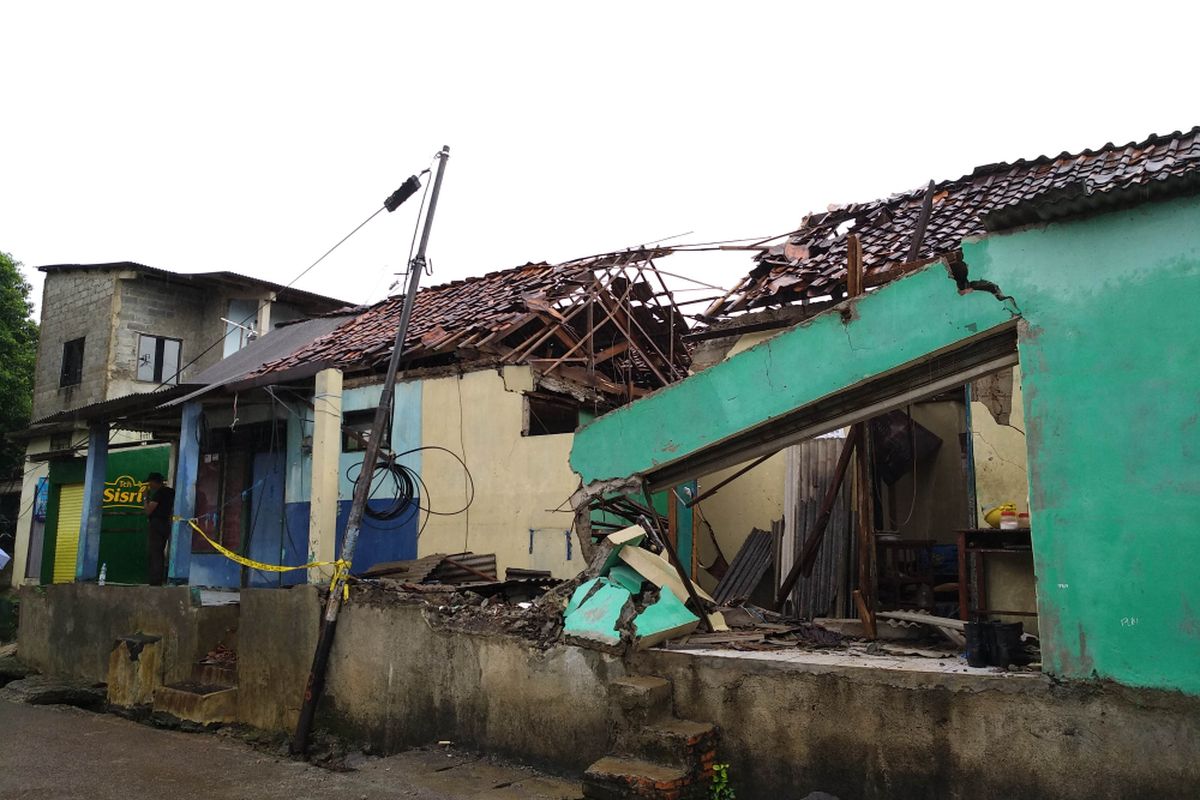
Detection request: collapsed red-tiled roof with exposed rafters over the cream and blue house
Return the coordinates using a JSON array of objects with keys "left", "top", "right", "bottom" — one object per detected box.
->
[{"left": 258, "top": 248, "right": 691, "bottom": 402}]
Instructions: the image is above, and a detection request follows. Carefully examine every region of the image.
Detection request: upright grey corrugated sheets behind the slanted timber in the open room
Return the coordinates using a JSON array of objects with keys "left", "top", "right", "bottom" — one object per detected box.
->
[{"left": 775, "top": 437, "right": 857, "bottom": 619}]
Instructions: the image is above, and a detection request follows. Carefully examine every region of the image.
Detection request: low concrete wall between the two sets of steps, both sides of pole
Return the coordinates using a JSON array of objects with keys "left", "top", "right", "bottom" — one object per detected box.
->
[{"left": 238, "top": 587, "right": 625, "bottom": 772}]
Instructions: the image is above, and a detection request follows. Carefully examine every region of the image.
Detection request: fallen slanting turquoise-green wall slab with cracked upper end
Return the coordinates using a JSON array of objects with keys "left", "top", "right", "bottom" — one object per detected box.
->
[{"left": 571, "top": 264, "right": 1014, "bottom": 483}]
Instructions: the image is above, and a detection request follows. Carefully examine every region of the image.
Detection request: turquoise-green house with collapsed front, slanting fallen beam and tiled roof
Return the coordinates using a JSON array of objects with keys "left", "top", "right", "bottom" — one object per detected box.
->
[{"left": 571, "top": 130, "right": 1200, "bottom": 692}]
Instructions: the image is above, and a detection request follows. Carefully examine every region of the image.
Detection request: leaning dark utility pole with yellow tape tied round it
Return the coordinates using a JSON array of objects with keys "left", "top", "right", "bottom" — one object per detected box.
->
[{"left": 292, "top": 146, "right": 450, "bottom": 754}]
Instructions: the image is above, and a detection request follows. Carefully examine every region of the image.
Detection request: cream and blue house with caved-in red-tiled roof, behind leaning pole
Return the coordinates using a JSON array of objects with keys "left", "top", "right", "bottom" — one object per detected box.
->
[{"left": 14, "top": 251, "right": 690, "bottom": 588}]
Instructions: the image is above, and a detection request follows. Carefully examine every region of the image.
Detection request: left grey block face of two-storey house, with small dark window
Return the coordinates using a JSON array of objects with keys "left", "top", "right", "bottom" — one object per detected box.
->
[{"left": 32, "top": 271, "right": 115, "bottom": 420}]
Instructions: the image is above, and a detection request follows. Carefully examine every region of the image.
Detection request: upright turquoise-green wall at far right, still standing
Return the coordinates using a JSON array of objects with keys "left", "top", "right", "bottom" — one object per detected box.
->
[{"left": 964, "top": 198, "right": 1200, "bottom": 693}]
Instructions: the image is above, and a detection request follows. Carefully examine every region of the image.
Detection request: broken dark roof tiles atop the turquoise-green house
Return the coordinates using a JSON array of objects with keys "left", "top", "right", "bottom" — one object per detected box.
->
[{"left": 706, "top": 127, "right": 1200, "bottom": 315}]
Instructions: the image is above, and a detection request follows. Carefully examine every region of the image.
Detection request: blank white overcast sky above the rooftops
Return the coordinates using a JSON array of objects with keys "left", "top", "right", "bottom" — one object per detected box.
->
[{"left": 0, "top": 1, "right": 1200, "bottom": 316}]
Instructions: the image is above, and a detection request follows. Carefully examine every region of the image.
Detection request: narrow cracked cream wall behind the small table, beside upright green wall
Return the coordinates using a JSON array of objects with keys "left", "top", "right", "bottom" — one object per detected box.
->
[{"left": 971, "top": 367, "right": 1037, "bottom": 632}]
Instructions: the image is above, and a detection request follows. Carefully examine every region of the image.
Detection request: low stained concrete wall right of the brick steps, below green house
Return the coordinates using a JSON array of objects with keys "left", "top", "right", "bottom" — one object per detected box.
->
[{"left": 636, "top": 651, "right": 1200, "bottom": 800}]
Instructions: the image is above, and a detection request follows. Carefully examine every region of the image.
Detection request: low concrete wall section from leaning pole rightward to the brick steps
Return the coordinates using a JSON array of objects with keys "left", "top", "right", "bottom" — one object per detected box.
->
[{"left": 320, "top": 602, "right": 625, "bottom": 772}]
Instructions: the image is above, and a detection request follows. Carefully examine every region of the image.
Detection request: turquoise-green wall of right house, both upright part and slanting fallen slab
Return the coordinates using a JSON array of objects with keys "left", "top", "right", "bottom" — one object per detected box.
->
[{"left": 571, "top": 198, "right": 1200, "bottom": 694}]
